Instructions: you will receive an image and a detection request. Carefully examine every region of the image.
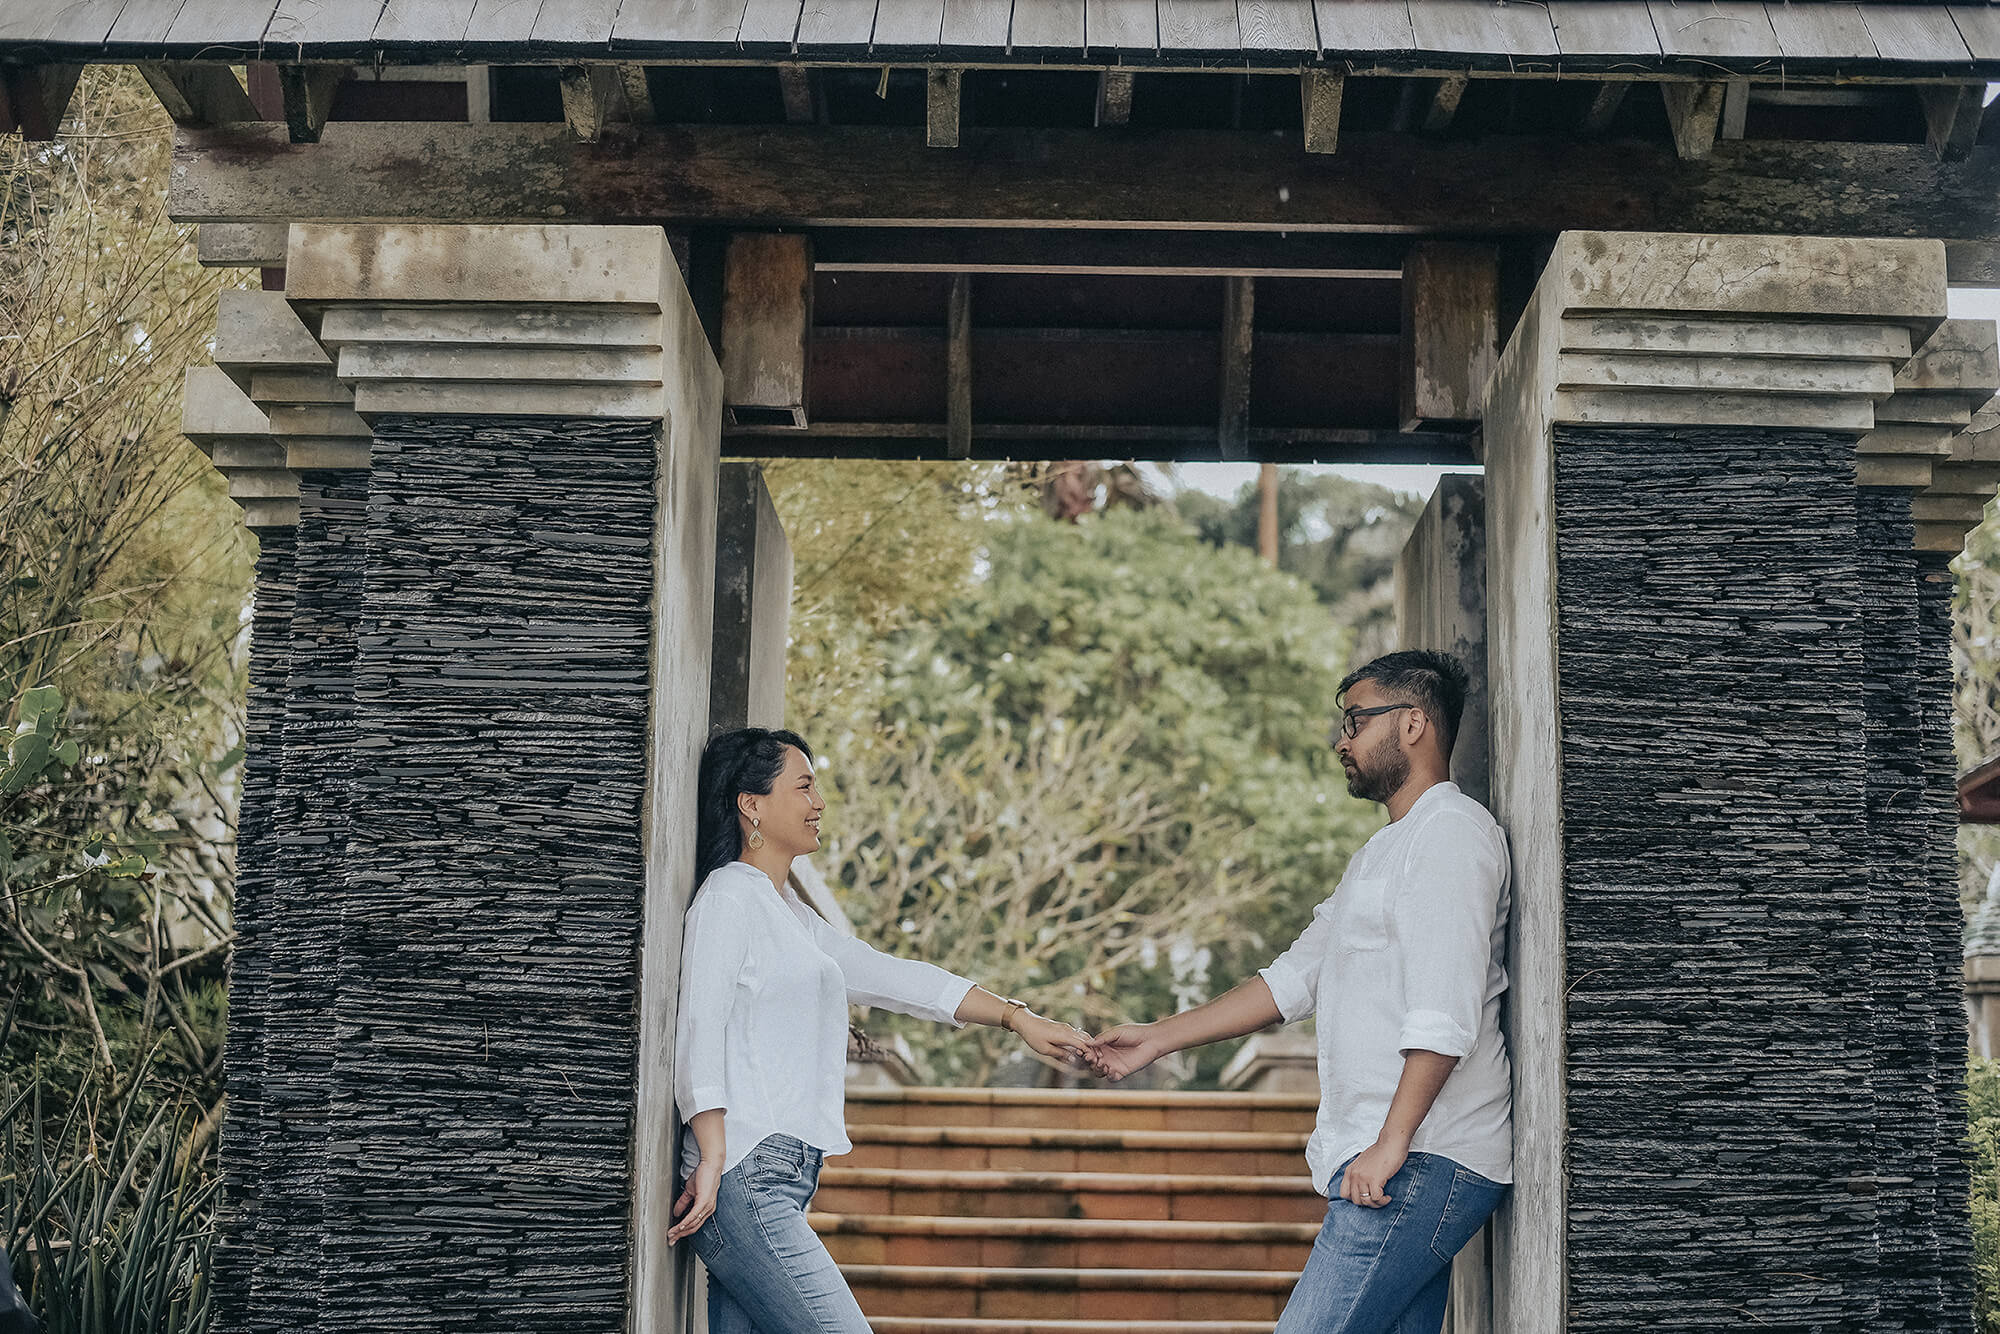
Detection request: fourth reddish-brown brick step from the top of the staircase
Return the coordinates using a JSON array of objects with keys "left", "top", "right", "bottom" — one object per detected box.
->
[{"left": 812, "top": 1214, "right": 1318, "bottom": 1270}]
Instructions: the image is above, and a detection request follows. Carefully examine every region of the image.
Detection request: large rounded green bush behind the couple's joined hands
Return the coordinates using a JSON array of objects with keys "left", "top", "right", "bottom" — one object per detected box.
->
[{"left": 792, "top": 512, "right": 1378, "bottom": 1080}]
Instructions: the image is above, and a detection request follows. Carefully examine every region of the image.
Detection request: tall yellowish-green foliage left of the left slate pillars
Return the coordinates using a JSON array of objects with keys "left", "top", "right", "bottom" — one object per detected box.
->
[{"left": 0, "top": 70, "right": 250, "bottom": 1116}]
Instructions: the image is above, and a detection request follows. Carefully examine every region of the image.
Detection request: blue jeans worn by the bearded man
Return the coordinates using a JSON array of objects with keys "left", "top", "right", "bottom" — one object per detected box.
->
[{"left": 1276, "top": 1154, "right": 1506, "bottom": 1334}]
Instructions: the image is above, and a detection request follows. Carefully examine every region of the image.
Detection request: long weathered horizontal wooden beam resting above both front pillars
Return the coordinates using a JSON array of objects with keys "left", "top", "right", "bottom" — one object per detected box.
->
[{"left": 170, "top": 122, "right": 2000, "bottom": 282}]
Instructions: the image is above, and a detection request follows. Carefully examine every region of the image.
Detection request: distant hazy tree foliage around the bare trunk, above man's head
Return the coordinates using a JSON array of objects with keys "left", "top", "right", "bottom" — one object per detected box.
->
[{"left": 1174, "top": 468, "right": 1424, "bottom": 660}]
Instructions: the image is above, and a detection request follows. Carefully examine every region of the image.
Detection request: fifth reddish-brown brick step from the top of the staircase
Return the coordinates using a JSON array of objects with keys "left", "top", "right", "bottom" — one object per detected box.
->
[{"left": 840, "top": 1264, "right": 1298, "bottom": 1324}]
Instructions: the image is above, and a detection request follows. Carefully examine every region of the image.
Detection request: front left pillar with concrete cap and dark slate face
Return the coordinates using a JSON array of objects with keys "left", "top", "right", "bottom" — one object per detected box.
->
[{"left": 193, "top": 226, "right": 720, "bottom": 1330}]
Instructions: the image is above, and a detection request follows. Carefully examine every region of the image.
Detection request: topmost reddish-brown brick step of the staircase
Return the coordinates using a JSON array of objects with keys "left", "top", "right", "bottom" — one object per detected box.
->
[{"left": 848, "top": 1088, "right": 1318, "bottom": 1132}]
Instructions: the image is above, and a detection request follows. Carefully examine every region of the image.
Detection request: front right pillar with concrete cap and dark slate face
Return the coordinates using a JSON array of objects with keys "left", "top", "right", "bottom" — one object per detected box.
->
[{"left": 1484, "top": 234, "right": 1966, "bottom": 1332}]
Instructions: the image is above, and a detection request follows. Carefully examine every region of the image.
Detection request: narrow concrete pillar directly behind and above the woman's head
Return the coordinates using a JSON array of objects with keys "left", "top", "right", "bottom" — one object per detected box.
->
[{"left": 708, "top": 464, "right": 792, "bottom": 732}]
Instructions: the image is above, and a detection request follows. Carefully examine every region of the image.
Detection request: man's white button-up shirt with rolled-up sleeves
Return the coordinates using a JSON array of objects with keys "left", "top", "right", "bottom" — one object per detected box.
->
[{"left": 1260, "top": 782, "right": 1514, "bottom": 1194}]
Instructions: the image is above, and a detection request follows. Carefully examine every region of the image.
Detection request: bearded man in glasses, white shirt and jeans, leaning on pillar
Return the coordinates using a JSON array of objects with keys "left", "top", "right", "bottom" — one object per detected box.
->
[{"left": 1092, "top": 652, "right": 1514, "bottom": 1334}]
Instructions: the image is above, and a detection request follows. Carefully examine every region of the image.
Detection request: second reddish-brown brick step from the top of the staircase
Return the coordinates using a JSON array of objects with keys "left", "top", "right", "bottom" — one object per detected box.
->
[{"left": 846, "top": 1124, "right": 1306, "bottom": 1176}]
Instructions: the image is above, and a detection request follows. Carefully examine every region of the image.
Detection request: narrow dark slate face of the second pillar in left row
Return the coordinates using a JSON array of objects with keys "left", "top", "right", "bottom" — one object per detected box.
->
[{"left": 248, "top": 470, "right": 368, "bottom": 1334}]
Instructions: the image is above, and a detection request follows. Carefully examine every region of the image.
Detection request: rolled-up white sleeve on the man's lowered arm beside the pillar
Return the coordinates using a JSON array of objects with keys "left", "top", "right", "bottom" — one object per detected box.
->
[{"left": 1388, "top": 816, "right": 1506, "bottom": 1058}]
